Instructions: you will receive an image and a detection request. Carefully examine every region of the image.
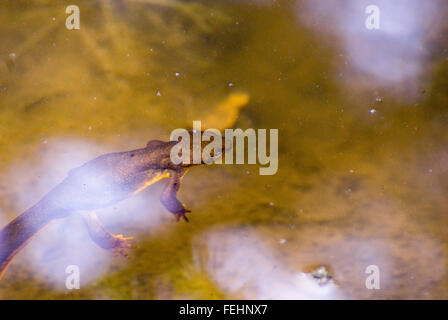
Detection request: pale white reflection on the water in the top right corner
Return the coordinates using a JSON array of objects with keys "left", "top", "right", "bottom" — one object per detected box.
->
[{"left": 298, "top": 0, "right": 442, "bottom": 83}]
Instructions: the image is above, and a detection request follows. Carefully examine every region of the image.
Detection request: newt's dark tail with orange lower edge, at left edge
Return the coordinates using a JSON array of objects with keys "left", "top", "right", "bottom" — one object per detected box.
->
[{"left": 0, "top": 203, "right": 54, "bottom": 279}]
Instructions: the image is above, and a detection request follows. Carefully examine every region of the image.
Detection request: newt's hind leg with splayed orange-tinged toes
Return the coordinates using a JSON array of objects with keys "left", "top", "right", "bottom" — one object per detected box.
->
[{"left": 80, "top": 212, "right": 137, "bottom": 257}]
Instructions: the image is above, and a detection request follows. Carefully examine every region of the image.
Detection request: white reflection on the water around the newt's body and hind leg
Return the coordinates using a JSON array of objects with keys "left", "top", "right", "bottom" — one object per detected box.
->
[{"left": 0, "top": 139, "right": 167, "bottom": 284}]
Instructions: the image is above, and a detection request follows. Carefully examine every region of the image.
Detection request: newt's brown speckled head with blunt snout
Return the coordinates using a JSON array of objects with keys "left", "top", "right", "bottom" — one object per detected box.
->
[{"left": 170, "top": 130, "right": 232, "bottom": 167}]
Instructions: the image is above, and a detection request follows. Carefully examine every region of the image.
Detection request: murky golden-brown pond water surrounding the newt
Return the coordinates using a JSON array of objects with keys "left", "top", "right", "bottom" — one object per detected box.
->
[{"left": 0, "top": 0, "right": 448, "bottom": 299}]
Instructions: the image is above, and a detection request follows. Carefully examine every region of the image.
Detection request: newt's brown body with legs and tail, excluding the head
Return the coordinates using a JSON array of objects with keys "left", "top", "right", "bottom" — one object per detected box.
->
[{"left": 0, "top": 132, "right": 225, "bottom": 278}]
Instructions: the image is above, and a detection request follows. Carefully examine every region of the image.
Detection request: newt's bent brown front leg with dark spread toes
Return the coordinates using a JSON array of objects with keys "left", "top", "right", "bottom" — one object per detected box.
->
[{"left": 160, "top": 169, "right": 191, "bottom": 222}]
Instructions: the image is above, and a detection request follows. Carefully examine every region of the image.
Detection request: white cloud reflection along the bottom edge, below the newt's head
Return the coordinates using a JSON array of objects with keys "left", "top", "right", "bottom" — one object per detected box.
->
[{"left": 194, "top": 228, "right": 343, "bottom": 299}]
